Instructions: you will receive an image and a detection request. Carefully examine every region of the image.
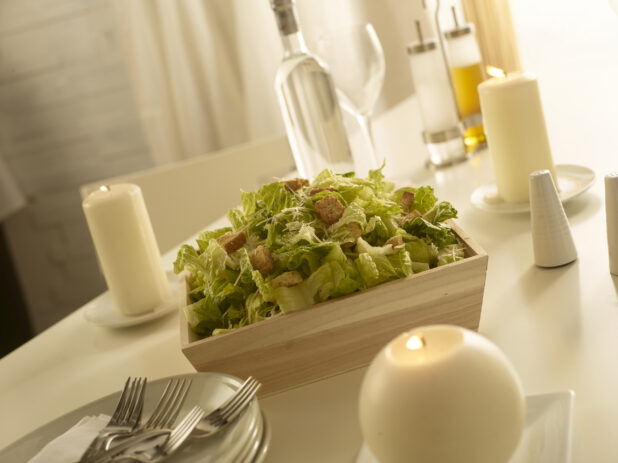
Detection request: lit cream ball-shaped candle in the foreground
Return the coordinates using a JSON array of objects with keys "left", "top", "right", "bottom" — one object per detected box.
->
[{"left": 359, "top": 325, "right": 525, "bottom": 463}]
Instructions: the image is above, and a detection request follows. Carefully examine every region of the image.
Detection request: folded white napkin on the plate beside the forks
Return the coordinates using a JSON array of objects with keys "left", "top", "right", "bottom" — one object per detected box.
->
[{"left": 28, "top": 415, "right": 110, "bottom": 463}]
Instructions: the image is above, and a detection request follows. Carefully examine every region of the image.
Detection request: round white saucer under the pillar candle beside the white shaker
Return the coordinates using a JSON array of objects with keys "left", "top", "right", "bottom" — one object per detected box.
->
[{"left": 470, "top": 164, "right": 595, "bottom": 214}]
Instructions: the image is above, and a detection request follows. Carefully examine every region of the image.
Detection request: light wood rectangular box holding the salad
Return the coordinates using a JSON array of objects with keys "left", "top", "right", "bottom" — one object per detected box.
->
[{"left": 179, "top": 221, "right": 488, "bottom": 396}]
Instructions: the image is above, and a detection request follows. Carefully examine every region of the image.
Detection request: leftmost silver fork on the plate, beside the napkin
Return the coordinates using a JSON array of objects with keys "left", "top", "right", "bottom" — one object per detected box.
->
[{"left": 79, "top": 377, "right": 146, "bottom": 463}]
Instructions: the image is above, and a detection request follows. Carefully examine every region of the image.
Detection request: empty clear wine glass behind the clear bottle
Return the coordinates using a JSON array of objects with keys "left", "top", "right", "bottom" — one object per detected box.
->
[{"left": 313, "top": 24, "right": 386, "bottom": 169}]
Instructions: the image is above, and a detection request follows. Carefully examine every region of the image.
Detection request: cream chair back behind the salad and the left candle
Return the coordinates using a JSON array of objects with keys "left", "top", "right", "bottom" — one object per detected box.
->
[{"left": 80, "top": 135, "right": 294, "bottom": 253}]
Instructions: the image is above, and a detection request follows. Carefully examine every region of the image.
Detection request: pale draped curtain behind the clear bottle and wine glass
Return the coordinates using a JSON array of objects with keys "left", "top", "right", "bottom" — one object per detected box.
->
[{"left": 115, "top": 0, "right": 420, "bottom": 164}]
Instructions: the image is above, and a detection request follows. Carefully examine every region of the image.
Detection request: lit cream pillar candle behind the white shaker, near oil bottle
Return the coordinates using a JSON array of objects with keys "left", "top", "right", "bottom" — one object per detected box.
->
[{"left": 478, "top": 72, "right": 558, "bottom": 202}]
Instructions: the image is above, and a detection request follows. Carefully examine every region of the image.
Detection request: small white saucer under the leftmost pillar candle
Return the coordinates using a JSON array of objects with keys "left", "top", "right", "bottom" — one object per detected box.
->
[{"left": 84, "top": 272, "right": 178, "bottom": 328}]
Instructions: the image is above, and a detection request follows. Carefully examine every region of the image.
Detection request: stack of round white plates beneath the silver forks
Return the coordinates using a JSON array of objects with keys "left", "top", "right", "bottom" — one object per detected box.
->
[{"left": 0, "top": 373, "right": 270, "bottom": 463}]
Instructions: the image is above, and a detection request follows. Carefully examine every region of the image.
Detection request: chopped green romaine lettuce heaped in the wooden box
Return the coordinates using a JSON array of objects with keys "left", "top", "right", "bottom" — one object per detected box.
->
[{"left": 174, "top": 166, "right": 464, "bottom": 336}]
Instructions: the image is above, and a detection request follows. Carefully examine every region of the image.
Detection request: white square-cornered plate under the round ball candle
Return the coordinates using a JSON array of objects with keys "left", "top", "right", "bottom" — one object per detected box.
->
[{"left": 356, "top": 391, "right": 575, "bottom": 463}]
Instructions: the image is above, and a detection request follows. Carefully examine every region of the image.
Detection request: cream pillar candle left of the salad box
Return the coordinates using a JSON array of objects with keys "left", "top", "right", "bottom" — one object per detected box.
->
[{"left": 82, "top": 184, "right": 171, "bottom": 315}]
